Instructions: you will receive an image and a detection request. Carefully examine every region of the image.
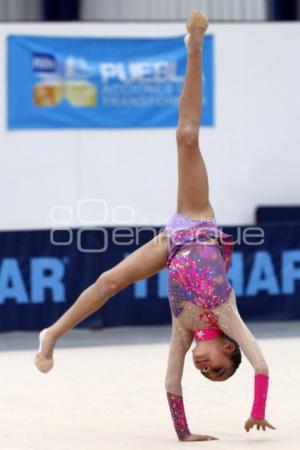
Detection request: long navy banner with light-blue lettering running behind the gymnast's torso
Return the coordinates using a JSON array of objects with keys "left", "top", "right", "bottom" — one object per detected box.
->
[{"left": 0, "top": 224, "right": 300, "bottom": 331}]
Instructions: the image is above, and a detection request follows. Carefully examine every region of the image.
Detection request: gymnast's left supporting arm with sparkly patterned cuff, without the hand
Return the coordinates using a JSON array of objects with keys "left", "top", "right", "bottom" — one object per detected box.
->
[{"left": 165, "top": 316, "right": 193, "bottom": 440}]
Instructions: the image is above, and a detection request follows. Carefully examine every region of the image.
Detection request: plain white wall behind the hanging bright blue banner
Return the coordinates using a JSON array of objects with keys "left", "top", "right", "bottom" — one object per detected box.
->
[{"left": 0, "top": 23, "right": 300, "bottom": 230}]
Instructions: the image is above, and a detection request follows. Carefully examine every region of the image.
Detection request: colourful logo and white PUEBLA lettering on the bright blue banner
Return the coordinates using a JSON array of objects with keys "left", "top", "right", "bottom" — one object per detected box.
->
[{"left": 32, "top": 54, "right": 183, "bottom": 108}]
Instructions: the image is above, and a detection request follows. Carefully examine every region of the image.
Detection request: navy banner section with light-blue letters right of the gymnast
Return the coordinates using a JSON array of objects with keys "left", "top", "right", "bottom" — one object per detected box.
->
[{"left": 227, "top": 224, "right": 300, "bottom": 320}]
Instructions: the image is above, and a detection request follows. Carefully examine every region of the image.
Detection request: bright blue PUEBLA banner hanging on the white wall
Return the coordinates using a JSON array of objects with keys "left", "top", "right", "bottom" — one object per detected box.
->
[{"left": 7, "top": 35, "right": 214, "bottom": 129}]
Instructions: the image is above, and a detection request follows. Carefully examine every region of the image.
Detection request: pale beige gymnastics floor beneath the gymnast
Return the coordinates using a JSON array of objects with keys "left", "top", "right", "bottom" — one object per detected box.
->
[{"left": 0, "top": 322, "right": 300, "bottom": 450}]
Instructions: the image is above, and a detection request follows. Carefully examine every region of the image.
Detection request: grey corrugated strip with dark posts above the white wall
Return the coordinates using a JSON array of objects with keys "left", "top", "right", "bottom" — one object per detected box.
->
[{"left": 0, "top": 0, "right": 300, "bottom": 22}]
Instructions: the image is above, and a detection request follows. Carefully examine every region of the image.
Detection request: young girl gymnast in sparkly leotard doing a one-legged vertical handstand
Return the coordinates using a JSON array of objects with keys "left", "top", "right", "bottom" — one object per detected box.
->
[{"left": 35, "top": 11, "right": 274, "bottom": 441}]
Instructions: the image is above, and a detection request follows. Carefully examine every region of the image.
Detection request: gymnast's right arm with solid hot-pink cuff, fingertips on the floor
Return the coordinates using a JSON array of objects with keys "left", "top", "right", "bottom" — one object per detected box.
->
[{"left": 216, "top": 291, "right": 274, "bottom": 431}]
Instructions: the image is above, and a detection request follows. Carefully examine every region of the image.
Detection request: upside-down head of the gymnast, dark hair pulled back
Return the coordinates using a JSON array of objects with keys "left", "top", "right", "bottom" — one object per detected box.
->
[{"left": 192, "top": 333, "right": 242, "bottom": 381}]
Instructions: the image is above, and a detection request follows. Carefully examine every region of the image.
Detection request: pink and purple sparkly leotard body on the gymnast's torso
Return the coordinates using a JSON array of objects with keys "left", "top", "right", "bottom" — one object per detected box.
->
[{"left": 166, "top": 213, "right": 233, "bottom": 317}]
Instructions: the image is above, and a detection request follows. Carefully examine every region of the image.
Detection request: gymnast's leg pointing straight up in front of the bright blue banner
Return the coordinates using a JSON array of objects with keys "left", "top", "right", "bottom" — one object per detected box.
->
[{"left": 176, "top": 11, "right": 214, "bottom": 219}]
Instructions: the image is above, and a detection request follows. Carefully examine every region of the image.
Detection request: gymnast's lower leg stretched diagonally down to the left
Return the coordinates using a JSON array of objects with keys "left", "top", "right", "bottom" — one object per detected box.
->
[{"left": 35, "top": 233, "right": 168, "bottom": 372}]
